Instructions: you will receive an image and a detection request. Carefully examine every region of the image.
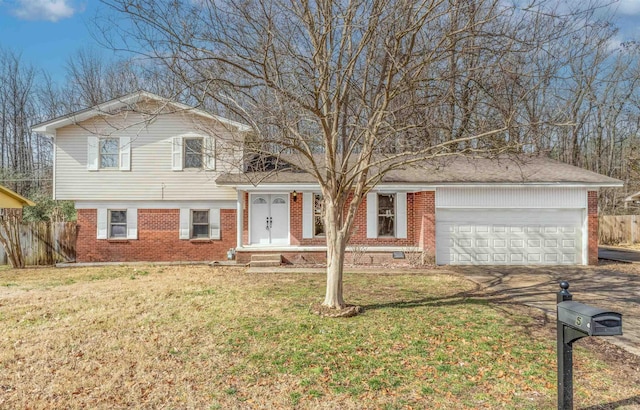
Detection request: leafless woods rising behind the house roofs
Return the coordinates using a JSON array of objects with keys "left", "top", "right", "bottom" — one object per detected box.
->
[{"left": 0, "top": 0, "right": 640, "bottom": 212}]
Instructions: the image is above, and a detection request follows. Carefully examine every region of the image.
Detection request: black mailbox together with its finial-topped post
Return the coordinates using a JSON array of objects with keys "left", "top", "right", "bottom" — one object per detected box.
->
[{"left": 556, "top": 281, "right": 622, "bottom": 410}]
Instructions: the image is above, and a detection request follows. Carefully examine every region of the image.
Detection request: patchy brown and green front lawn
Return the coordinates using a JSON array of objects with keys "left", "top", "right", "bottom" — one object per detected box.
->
[{"left": 0, "top": 266, "right": 640, "bottom": 409}]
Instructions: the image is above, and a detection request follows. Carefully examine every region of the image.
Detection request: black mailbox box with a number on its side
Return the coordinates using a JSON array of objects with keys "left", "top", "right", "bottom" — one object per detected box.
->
[{"left": 558, "top": 300, "right": 622, "bottom": 336}]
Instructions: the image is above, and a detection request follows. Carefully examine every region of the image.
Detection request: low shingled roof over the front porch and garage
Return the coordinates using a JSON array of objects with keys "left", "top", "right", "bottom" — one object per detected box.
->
[{"left": 216, "top": 155, "right": 623, "bottom": 187}]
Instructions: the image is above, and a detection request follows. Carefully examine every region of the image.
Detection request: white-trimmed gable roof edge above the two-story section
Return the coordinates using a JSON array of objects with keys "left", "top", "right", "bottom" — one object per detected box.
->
[{"left": 31, "top": 91, "right": 251, "bottom": 135}]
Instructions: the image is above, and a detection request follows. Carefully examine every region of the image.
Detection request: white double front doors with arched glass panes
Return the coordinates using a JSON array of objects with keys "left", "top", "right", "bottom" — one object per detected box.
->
[{"left": 250, "top": 194, "right": 289, "bottom": 245}]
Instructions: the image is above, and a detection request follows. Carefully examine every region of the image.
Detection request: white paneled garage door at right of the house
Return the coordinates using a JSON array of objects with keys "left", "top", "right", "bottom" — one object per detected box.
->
[{"left": 436, "top": 209, "right": 582, "bottom": 265}]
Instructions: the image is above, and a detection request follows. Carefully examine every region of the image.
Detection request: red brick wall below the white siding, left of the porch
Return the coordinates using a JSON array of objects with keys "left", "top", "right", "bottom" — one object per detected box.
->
[{"left": 76, "top": 209, "right": 236, "bottom": 262}]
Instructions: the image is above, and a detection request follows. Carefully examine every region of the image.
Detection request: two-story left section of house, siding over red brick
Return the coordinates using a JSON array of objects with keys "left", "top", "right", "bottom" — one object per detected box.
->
[{"left": 34, "top": 92, "right": 248, "bottom": 261}]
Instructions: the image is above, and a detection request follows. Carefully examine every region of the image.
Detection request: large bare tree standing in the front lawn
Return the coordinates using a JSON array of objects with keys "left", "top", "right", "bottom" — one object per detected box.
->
[{"left": 96, "top": 0, "right": 616, "bottom": 309}]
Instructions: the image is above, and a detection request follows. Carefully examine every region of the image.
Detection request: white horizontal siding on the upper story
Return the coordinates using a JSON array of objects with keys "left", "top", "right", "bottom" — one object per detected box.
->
[{"left": 54, "top": 113, "right": 242, "bottom": 202}]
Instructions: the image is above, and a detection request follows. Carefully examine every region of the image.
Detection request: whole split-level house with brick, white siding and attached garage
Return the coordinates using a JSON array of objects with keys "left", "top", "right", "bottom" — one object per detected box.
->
[{"left": 34, "top": 92, "right": 622, "bottom": 265}]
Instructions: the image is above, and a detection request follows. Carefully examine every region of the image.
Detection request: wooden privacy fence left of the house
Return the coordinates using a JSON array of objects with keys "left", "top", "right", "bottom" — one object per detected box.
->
[{"left": 0, "top": 222, "right": 76, "bottom": 266}]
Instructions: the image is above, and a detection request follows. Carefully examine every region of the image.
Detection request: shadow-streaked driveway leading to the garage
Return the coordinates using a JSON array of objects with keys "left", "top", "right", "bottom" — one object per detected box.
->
[{"left": 455, "top": 261, "right": 640, "bottom": 356}]
